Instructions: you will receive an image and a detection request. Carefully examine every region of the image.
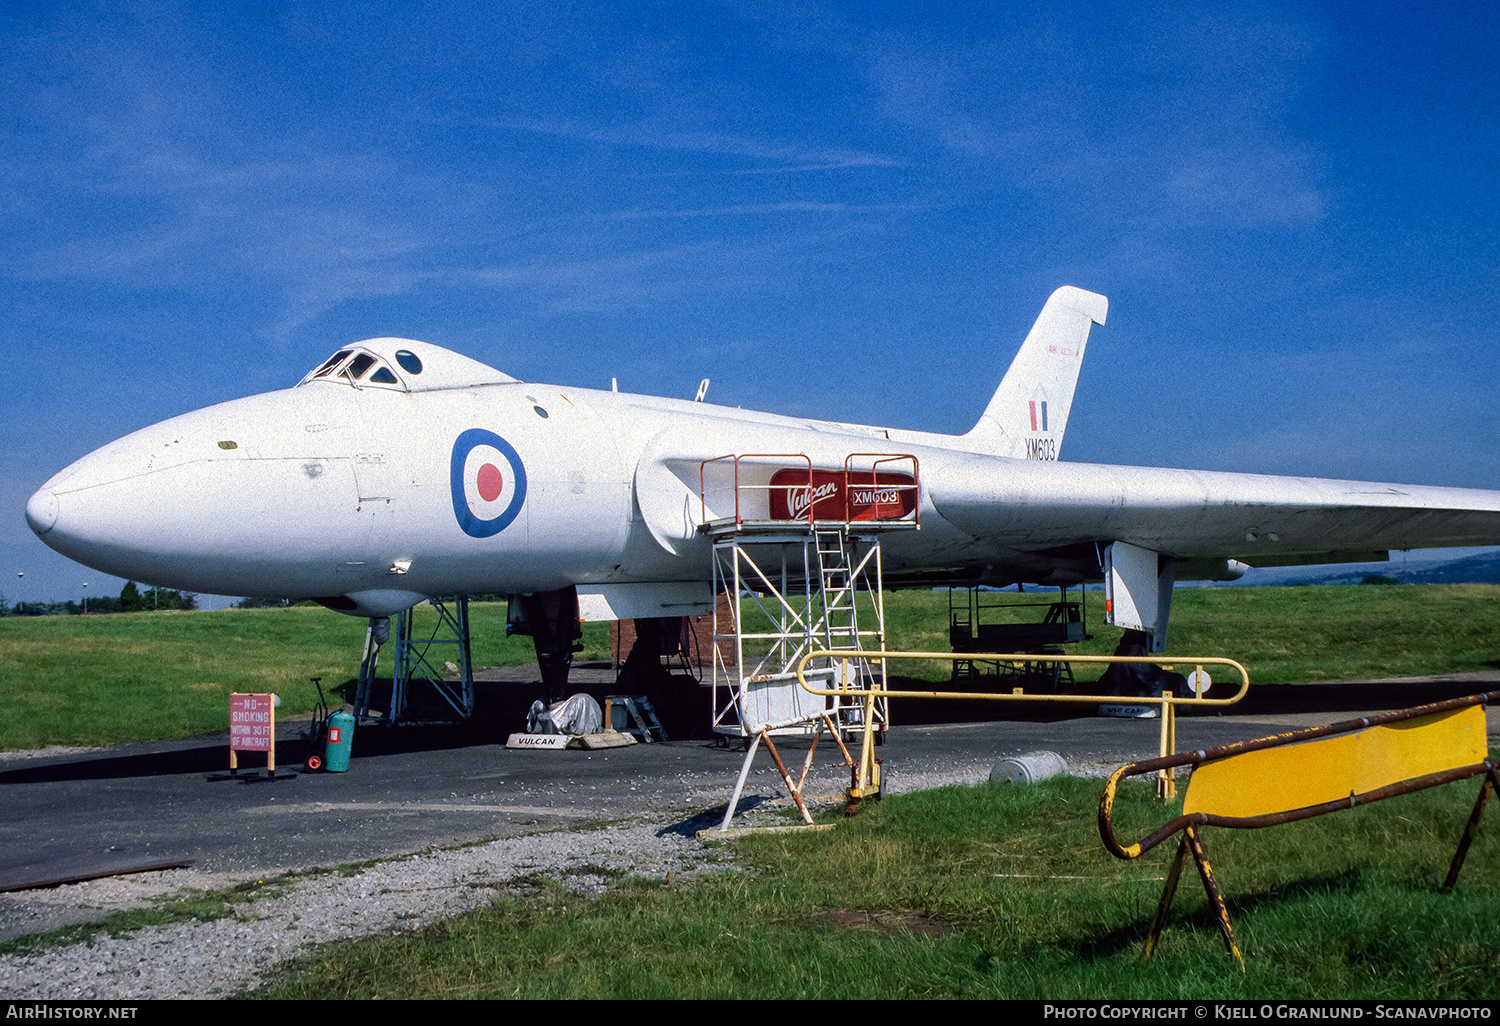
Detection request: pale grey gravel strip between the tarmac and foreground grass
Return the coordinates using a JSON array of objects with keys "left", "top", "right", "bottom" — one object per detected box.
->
[{"left": 0, "top": 767, "right": 983, "bottom": 1001}]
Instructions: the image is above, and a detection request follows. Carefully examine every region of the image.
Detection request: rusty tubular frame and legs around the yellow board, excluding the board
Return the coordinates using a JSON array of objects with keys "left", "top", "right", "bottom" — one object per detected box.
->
[{"left": 1100, "top": 692, "right": 1500, "bottom": 971}]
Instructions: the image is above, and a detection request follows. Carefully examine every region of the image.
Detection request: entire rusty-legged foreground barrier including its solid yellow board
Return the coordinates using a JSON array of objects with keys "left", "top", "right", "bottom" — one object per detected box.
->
[{"left": 1100, "top": 692, "right": 1500, "bottom": 969}]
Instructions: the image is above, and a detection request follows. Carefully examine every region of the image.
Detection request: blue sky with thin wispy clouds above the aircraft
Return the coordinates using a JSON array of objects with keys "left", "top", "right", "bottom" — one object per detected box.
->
[{"left": 0, "top": 0, "right": 1500, "bottom": 602}]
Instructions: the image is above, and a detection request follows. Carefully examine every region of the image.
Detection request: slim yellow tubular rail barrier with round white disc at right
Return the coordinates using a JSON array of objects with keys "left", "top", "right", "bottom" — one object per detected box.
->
[{"left": 797, "top": 650, "right": 1250, "bottom": 807}]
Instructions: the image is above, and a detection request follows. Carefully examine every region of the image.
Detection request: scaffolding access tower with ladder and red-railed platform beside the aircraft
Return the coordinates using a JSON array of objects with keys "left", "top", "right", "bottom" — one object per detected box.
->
[{"left": 701, "top": 453, "right": 918, "bottom": 738}]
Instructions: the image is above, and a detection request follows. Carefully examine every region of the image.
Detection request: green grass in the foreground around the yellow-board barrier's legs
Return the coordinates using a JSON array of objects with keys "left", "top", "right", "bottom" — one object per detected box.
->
[{"left": 258, "top": 779, "right": 1500, "bottom": 1001}]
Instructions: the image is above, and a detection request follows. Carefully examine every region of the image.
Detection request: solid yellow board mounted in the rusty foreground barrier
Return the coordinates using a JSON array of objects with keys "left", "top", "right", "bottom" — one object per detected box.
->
[{"left": 1182, "top": 705, "right": 1488, "bottom": 818}]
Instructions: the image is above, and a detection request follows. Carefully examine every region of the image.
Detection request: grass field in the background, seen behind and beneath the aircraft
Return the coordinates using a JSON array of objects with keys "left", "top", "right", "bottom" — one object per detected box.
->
[{"left": 0, "top": 585, "right": 1500, "bottom": 750}]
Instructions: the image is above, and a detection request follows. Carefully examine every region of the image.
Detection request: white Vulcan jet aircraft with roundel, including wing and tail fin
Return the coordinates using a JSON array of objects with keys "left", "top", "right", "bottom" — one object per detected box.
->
[{"left": 27, "top": 288, "right": 1500, "bottom": 630}]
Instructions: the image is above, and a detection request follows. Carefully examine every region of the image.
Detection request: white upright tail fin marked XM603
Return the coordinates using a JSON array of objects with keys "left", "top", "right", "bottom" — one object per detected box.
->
[{"left": 962, "top": 285, "right": 1110, "bottom": 459}]
